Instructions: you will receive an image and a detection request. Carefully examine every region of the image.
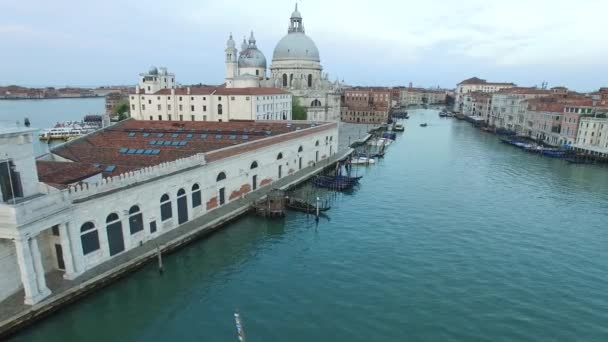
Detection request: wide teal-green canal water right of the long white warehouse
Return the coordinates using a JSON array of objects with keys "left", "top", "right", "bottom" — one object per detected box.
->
[{"left": 8, "top": 110, "right": 608, "bottom": 342}]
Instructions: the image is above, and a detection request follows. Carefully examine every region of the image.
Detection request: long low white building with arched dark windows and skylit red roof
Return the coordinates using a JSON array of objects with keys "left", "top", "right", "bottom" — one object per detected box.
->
[{"left": 0, "top": 118, "right": 338, "bottom": 305}]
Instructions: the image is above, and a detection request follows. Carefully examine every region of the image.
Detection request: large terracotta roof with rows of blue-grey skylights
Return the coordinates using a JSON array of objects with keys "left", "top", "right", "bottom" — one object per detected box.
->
[{"left": 51, "top": 119, "right": 327, "bottom": 176}]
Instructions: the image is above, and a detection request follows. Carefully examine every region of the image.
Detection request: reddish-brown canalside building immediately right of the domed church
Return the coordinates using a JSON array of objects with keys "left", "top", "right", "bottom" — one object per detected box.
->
[{"left": 341, "top": 87, "right": 393, "bottom": 124}]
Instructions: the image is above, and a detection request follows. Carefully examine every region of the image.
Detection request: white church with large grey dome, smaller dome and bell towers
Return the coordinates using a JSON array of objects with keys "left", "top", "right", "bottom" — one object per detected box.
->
[{"left": 225, "top": 4, "right": 342, "bottom": 121}]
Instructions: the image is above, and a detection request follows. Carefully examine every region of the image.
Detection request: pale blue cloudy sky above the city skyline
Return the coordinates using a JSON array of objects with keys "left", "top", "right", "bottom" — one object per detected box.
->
[{"left": 0, "top": 0, "right": 608, "bottom": 91}]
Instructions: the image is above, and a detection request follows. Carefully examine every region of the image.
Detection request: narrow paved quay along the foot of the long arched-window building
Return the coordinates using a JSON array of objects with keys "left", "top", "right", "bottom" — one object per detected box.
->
[{"left": 0, "top": 149, "right": 351, "bottom": 338}]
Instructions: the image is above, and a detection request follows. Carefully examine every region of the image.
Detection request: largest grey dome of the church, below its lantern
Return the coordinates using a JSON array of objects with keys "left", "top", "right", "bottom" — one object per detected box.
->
[{"left": 272, "top": 32, "right": 321, "bottom": 62}]
